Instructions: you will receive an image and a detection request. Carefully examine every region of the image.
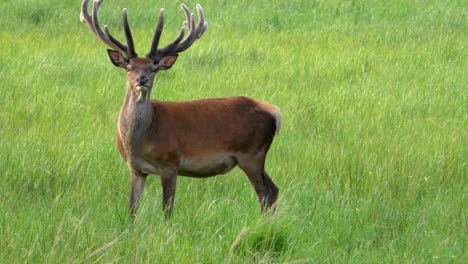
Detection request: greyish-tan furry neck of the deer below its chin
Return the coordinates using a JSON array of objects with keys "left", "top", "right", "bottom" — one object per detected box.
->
[{"left": 119, "top": 84, "right": 153, "bottom": 150}]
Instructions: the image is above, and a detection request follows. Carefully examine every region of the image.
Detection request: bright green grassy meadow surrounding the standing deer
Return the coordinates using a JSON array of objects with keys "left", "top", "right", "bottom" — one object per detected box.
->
[{"left": 0, "top": 0, "right": 468, "bottom": 263}]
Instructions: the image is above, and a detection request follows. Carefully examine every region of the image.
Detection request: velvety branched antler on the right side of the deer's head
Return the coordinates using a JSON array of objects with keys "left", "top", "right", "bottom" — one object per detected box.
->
[{"left": 146, "top": 4, "right": 208, "bottom": 61}]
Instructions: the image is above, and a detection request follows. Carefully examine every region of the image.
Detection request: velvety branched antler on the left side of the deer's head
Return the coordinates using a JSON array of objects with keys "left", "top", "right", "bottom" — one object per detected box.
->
[{"left": 80, "top": 0, "right": 138, "bottom": 59}]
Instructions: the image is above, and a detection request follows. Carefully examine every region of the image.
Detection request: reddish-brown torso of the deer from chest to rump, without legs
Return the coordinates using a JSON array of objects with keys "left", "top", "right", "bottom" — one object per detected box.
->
[{"left": 117, "top": 97, "right": 280, "bottom": 177}]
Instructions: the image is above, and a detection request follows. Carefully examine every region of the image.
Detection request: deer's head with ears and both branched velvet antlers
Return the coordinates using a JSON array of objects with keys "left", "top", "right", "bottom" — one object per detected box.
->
[{"left": 81, "top": 0, "right": 208, "bottom": 98}]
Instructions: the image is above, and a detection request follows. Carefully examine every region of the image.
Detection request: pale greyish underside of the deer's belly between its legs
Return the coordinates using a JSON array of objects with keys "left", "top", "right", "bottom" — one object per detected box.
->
[{"left": 178, "top": 156, "right": 237, "bottom": 177}]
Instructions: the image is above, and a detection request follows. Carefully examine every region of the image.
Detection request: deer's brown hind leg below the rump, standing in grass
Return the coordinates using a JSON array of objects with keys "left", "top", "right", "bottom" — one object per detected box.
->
[{"left": 238, "top": 153, "right": 279, "bottom": 212}]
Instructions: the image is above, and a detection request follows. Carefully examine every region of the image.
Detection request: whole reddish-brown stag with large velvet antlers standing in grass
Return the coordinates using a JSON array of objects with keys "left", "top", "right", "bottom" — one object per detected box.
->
[{"left": 80, "top": 0, "right": 282, "bottom": 218}]
